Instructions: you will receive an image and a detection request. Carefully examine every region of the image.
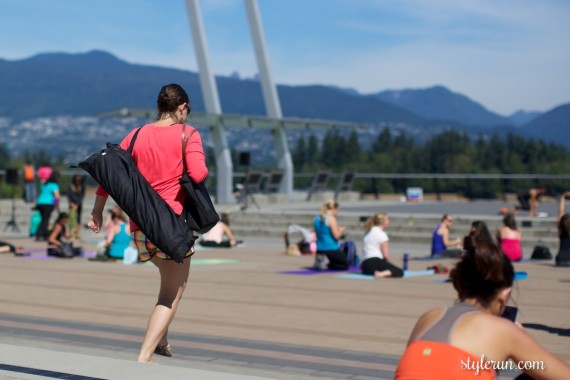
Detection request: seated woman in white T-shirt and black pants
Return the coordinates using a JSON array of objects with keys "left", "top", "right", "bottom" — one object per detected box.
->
[{"left": 360, "top": 212, "right": 404, "bottom": 278}]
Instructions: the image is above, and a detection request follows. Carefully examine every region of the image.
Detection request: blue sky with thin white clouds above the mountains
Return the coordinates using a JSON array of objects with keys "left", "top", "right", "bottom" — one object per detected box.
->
[{"left": 0, "top": 0, "right": 570, "bottom": 115}]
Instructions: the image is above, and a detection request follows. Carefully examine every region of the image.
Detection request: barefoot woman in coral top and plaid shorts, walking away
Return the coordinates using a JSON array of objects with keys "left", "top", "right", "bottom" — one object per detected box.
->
[{"left": 88, "top": 84, "right": 208, "bottom": 363}]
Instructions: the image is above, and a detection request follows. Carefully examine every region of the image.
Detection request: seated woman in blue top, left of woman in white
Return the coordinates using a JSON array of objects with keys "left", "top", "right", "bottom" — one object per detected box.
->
[{"left": 313, "top": 199, "right": 349, "bottom": 270}]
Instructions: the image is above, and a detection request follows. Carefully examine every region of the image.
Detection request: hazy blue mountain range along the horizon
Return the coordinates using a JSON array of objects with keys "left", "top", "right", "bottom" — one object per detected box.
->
[{"left": 0, "top": 51, "right": 570, "bottom": 147}]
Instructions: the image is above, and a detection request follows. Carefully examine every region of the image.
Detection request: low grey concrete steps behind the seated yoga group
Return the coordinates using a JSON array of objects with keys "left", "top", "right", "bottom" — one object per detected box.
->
[{"left": 0, "top": 197, "right": 558, "bottom": 252}]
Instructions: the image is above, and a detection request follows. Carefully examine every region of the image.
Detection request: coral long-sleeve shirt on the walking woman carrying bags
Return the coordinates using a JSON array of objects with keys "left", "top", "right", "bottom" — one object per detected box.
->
[{"left": 96, "top": 124, "right": 208, "bottom": 231}]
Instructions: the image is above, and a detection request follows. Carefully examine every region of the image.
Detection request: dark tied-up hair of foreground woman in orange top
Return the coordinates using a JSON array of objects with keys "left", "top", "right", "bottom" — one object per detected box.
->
[{"left": 450, "top": 240, "right": 515, "bottom": 307}]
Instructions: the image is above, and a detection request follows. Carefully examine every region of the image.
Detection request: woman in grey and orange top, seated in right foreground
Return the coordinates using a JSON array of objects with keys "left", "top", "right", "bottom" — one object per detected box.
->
[{"left": 395, "top": 240, "right": 570, "bottom": 380}]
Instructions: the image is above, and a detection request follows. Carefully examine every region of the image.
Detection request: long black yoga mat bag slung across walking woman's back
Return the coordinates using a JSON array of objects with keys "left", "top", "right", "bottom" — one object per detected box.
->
[{"left": 78, "top": 128, "right": 196, "bottom": 263}]
